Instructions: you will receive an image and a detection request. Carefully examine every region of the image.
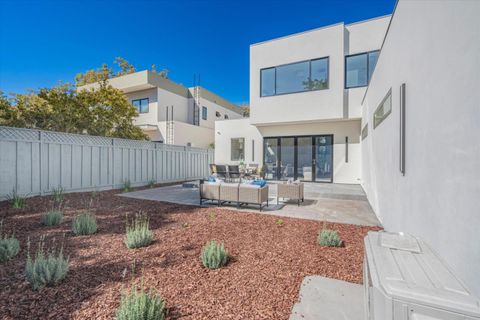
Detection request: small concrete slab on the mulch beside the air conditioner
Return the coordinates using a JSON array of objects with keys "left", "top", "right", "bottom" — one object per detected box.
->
[{"left": 289, "top": 276, "right": 364, "bottom": 320}]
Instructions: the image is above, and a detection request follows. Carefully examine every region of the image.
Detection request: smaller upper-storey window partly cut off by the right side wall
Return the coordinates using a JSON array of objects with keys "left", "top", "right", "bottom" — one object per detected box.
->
[{"left": 345, "top": 51, "right": 379, "bottom": 89}]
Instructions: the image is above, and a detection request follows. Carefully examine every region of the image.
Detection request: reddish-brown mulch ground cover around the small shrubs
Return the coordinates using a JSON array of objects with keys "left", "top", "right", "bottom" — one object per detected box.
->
[{"left": 0, "top": 186, "right": 378, "bottom": 319}]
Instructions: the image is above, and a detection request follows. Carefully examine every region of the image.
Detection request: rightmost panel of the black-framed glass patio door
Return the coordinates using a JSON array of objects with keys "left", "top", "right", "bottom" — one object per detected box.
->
[{"left": 314, "top": 136, "right": 333, "bottom": 182}]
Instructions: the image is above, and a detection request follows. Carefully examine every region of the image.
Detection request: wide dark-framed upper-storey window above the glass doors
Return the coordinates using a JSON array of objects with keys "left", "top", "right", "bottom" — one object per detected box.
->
[{"left": 260, "top": 58, "right": 328, "bottom": 97}]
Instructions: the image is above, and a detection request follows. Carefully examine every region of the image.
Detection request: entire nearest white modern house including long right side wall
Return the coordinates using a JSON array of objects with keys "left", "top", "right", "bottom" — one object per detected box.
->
[{"left": 215, "top": 0, "right": 480, "bottom": 298}]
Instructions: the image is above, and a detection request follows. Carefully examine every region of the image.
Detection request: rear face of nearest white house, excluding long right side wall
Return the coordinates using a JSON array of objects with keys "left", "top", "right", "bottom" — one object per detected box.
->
[{"left": 215, "top": 16, "right": 390, "bottom": 183}]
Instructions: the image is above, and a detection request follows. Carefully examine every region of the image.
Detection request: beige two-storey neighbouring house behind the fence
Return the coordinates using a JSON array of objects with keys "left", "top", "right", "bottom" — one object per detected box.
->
[{"left": 78, "top": 70, "right": 242, "bottom": 148}]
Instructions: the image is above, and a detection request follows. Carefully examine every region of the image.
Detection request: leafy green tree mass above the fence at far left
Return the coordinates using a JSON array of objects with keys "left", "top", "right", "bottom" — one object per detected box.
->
[{"left": 0, "top": 81, "right": 147, "bottom": 140}]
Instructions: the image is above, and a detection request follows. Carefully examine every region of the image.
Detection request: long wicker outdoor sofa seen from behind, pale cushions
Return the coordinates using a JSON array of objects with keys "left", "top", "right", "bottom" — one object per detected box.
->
[{"left": 199, "top": 181, "right": 268, "bottom": 211}]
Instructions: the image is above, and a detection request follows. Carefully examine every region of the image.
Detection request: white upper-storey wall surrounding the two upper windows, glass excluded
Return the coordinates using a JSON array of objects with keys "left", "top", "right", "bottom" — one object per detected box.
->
[{"left": 250, "top": 16, "right": 390, "bottom": 125}]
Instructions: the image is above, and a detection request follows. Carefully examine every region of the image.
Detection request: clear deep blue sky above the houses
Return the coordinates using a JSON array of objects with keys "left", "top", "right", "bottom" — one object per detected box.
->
[{"left": 0, "top": 0, "right": 395, "bottom": 103}]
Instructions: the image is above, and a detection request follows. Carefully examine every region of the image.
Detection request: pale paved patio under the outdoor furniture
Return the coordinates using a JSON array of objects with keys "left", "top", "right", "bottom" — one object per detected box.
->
[{"left": 121, "top": 182, "right": 380, "bottom": 226}]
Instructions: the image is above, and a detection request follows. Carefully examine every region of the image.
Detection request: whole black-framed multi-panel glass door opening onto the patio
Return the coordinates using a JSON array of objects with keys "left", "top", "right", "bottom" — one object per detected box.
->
[{"left": 263, "top": 135, "right": 333, "bottom": 182}]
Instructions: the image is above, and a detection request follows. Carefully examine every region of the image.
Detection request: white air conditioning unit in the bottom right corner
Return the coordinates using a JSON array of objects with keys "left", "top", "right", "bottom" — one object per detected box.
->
[{"left": 363, "top": 232, "right": 480, "bottom": 320}]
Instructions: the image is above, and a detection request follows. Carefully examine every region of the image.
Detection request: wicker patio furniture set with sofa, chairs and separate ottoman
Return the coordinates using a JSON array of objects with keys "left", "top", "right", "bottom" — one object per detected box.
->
[{"left": 199, "top": 165, "right": 304, "bottom": 211}]
